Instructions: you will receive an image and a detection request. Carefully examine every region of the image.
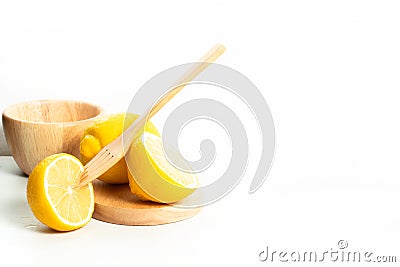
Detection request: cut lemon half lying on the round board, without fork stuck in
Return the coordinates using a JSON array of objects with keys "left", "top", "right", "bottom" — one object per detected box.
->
[{"left": 126, "top": 132, "right": 198, "bottom": 203}]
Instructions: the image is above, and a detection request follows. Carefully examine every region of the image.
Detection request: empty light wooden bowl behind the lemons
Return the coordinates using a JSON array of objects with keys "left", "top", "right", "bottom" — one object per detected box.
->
[{"left": 2, "top": 100, "right": 103, "bottom": 175}]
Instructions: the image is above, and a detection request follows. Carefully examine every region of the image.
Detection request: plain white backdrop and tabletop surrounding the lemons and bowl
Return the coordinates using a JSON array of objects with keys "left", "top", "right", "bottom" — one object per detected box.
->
[{"left": 0, "top": 0, "right": 400, "bottom": 266}]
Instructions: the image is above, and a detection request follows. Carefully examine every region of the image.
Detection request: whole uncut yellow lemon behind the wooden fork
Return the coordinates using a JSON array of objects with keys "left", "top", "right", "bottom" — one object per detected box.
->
[{"left": 80, "top": 113, "right": 159, "bottom": 184}]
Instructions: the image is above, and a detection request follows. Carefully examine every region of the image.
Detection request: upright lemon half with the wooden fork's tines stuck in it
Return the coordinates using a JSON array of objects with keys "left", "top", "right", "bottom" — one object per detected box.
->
[{"left": 26, "top": 153, "right": 94, "bottom": 231}]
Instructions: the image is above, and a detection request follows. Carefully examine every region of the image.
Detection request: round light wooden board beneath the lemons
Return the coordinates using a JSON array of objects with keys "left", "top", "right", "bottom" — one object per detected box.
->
[{"left": 93, "top": 180, "right": 200, "bottom": 225}]
